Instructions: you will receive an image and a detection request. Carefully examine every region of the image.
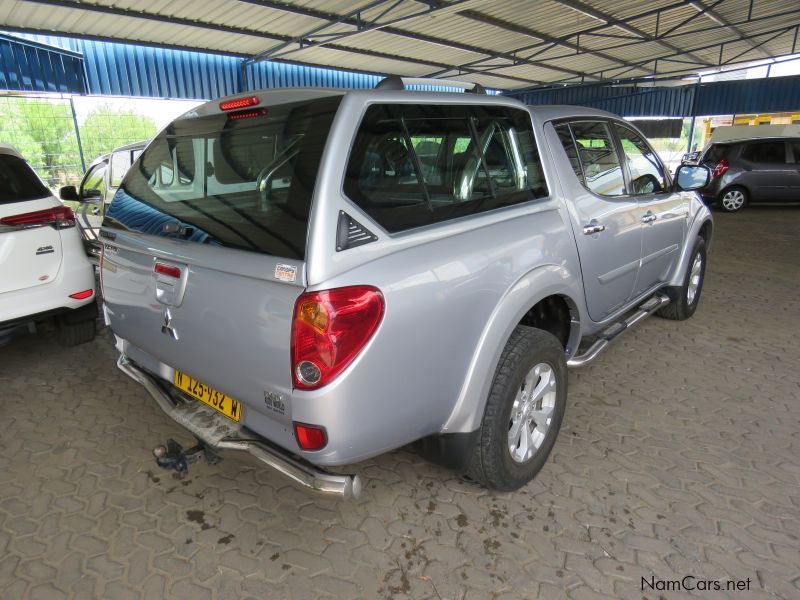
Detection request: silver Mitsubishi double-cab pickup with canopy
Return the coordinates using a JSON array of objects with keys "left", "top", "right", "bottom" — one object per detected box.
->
[{"left": 101, "top": 78, "right": 713, "bottom": 497}]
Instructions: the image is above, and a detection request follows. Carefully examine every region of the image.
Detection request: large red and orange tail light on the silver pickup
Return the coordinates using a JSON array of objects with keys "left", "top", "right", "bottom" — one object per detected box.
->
[{"left": 292, "top": 285, "right": 384, "bottom": 390}]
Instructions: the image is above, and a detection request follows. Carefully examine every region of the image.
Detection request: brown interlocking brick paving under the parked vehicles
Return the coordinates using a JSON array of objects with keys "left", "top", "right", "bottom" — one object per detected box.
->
[{"left": 0, "top": 208, "right": 800, "bottom": 600}]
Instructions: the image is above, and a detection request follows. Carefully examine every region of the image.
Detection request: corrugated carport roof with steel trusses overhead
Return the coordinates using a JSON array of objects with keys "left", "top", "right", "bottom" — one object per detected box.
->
[{"left": 0, "top": 0, "right": 800, "bottom": 90}]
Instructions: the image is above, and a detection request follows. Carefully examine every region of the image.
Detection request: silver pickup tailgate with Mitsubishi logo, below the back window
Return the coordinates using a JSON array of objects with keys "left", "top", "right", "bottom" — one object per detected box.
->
[{"left": 102, "top": 234, "right": 304, "bottom": 428}]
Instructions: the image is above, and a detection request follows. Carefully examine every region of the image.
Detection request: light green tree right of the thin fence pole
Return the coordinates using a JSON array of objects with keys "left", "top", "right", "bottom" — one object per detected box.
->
[{"left": 80, "top": 106, "right": 157, "bottom": 165}]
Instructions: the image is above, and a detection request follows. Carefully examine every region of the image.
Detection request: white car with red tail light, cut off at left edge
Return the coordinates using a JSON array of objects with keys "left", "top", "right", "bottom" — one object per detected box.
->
[{"left": 0, "top": 145, "right": 97, "bottom": 346}]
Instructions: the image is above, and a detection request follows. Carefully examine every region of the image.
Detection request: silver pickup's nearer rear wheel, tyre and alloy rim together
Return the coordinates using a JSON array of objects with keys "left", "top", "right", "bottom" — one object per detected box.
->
[{"left": 468, "top": 325, "right": 567, "bottom": 491}]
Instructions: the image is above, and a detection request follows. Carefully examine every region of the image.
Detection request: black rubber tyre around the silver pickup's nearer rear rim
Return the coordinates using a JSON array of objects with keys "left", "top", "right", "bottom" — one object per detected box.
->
[{"left": 468, "top": 325, "right": 567, "bottom": 491}]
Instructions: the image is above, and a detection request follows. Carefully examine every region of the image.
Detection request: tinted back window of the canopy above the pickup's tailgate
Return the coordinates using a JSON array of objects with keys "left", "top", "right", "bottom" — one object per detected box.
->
[{"left": 103, "top": 96, "right": 341, "bottom": 259}]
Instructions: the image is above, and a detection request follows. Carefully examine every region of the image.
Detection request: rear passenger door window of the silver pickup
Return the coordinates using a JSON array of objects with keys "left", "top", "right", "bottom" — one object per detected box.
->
[{"left": 570, "top": 121, "right": 625, "bottom": 196}]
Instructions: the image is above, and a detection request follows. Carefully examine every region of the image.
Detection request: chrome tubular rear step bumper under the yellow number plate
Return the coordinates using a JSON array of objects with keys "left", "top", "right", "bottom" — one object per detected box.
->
[{"left": 117, "top": 355, "right": 361, "bottom": 500}]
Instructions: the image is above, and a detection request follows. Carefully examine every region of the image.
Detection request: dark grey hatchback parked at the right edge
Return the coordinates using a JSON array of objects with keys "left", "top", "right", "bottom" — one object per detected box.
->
[{"left": 697, "top": 138, "right": 800, "bottom": 212}]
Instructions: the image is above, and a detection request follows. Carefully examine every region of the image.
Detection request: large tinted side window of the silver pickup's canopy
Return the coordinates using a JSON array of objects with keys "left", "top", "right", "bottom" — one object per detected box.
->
[{"left": 344, "top": 104, "right": 548, "bottom": 233}]
